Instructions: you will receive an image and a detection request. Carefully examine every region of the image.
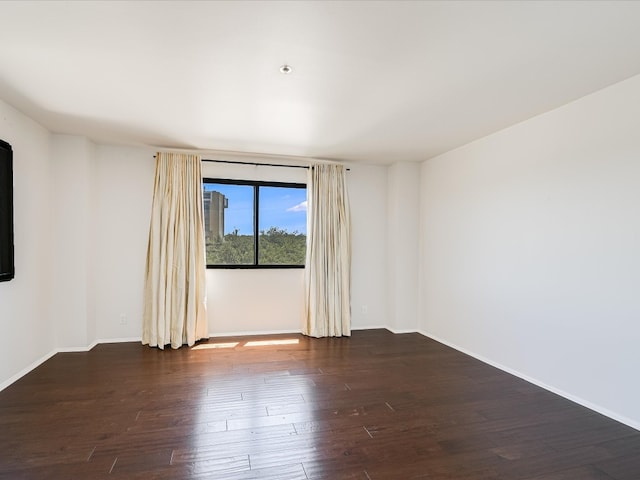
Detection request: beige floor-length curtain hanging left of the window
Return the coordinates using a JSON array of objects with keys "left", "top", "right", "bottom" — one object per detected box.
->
[{"left": 142, "top": 153, "right": 208, "bottom": 349}]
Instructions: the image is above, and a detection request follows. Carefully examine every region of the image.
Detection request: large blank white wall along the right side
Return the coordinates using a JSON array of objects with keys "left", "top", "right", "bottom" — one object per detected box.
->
[{"left": 420, "top": 72, "right": 640, "bottom": 427}]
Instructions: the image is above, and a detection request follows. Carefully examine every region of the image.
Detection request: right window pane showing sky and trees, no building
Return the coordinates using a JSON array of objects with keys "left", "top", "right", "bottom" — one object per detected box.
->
[{"left": 258, "top": 186, "right": 307, "bottom": 265}]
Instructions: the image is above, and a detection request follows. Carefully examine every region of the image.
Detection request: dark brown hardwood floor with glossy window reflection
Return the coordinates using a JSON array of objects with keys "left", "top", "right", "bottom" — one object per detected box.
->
[{"left": 0, "top": 330, "right": 640, "bottom": 480}]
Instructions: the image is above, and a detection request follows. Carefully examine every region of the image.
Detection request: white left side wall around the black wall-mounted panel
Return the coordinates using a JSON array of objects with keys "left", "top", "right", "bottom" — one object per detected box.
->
[{"left": 0, "top": 100, "right": 56, "bottom": 389}]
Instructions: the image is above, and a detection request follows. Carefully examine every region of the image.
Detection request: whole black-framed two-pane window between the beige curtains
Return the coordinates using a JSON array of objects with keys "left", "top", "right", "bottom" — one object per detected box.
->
[{"left": 202, "top": 178, "right": 307, "bottom": 268}]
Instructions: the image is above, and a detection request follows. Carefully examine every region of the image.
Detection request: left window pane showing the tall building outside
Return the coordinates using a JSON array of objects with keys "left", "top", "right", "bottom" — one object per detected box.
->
[{"left": 203, "top": 183, "right": 255, "bottom": 265}]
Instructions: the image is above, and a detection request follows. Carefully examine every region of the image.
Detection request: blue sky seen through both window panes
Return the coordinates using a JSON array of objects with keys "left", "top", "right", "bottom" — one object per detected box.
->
[{"left": 204, "top": 183, "right": 307, "bottom": 235}]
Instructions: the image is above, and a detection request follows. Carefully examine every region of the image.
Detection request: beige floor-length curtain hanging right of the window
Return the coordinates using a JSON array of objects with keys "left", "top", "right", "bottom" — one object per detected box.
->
[{"left": 302, "top": 164, "right": 351, "bottom": 337}]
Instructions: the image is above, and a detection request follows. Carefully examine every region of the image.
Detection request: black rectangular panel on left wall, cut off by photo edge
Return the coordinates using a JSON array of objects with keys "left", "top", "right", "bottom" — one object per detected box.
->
[{"left": 0, "top": 140, "right": 16, "bottom": 282}]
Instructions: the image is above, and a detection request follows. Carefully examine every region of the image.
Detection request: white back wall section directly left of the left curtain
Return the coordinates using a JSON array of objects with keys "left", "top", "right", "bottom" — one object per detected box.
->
[{"left": 93, "top": 145, "right": 155, "bottom": 340}]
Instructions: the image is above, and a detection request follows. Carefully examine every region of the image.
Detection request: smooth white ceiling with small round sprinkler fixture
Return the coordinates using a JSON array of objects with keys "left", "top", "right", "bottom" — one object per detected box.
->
[{"left": 0, "top": 1, "right": 640, "bottom": 163}]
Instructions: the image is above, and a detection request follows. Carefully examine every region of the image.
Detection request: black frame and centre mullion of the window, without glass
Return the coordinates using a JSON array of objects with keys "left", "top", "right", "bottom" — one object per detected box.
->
[{"left": 202, "top": 177, "right": 307, "bottom": 270}]
